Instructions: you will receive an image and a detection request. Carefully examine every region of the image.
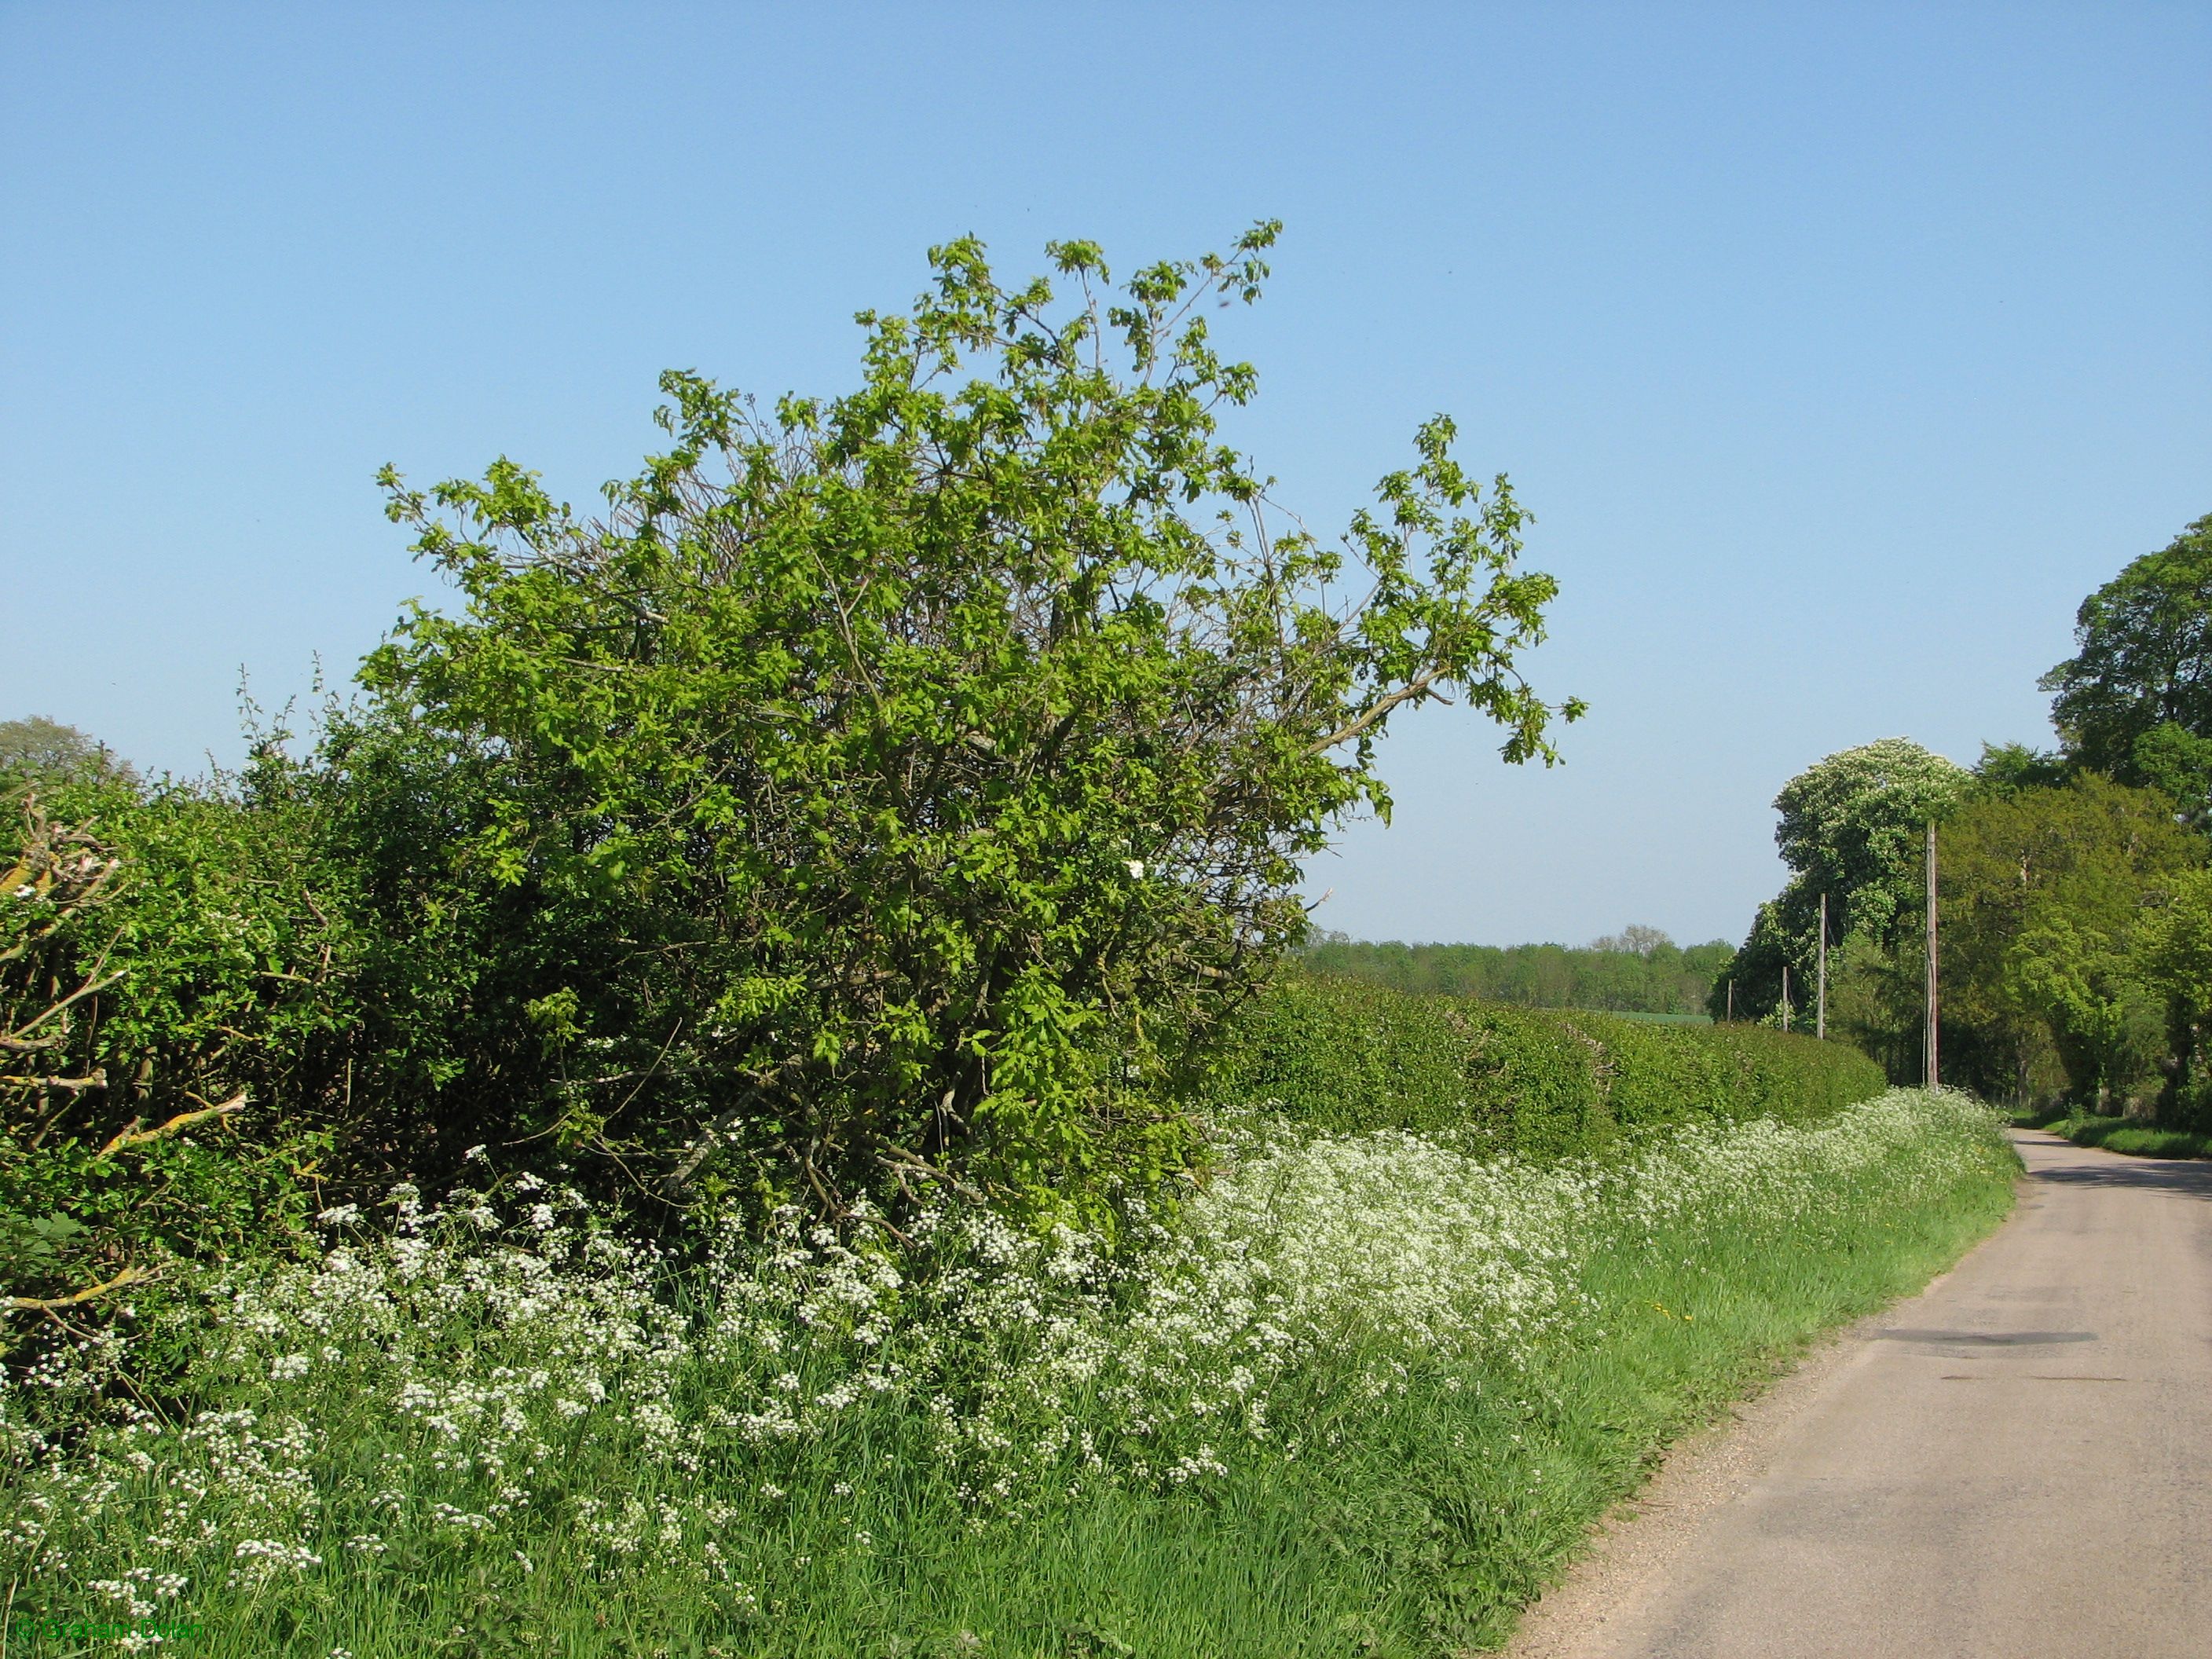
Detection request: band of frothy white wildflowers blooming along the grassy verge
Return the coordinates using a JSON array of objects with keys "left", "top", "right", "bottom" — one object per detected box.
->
[{"left": 0, "top": 1090, "right": 1993, "bottom": 1608}]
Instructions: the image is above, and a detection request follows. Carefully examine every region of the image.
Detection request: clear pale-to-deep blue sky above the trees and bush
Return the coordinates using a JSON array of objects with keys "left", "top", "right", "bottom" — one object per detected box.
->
[{"left": 0, "top": 0, "right": 2212, "bottom": 943}]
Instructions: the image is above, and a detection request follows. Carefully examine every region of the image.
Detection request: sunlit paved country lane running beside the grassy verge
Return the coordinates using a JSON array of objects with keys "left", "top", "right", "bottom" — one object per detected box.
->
[{"left": 1509, "top": 1130, "right": 2212, "bottom": 1659}]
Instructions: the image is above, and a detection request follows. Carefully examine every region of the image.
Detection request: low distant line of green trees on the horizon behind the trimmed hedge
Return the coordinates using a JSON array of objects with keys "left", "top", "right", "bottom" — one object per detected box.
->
[{"left": 1303, "top": 927, "right": 1732, "bottom": 1013}]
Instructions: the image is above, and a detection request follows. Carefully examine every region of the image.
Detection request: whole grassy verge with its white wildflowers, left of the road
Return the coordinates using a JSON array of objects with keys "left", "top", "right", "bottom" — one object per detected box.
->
[{"left": 0, "top": 1090, "right": 2013, "bottom": 1659}]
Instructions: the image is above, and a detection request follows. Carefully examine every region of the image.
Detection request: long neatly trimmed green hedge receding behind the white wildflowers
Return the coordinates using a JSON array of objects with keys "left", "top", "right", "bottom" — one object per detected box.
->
[{"left": 1214, "top": 976, "right": 1887, "bottom": 1157}]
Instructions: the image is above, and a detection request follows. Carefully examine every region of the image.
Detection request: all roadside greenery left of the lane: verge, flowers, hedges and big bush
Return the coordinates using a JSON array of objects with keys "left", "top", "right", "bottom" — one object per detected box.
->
[{"left": 0, "top": 225, "right": 2013, "bottom": 1659}]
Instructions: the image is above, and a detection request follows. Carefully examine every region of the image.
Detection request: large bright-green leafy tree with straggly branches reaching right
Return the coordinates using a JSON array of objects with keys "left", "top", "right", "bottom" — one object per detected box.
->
[{"left": 358, "top": 225, "right": 1580, "bottom": 1206}]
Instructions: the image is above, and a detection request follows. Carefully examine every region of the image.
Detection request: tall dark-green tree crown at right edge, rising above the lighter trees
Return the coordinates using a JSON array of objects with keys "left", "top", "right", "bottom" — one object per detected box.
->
[{"left": 2042, "top": 515, "right": 2212, "bottom": 814}]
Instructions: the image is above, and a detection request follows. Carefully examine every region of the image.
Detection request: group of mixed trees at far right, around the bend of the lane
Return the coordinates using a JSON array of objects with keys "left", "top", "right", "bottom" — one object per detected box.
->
[{"left": 1708, "top": 515, "right": 2212, "bottom": 1128}]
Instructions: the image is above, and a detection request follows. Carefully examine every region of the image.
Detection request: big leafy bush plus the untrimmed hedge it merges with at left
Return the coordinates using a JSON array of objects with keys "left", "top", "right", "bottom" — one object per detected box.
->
[{"left": 0, "top": 225, "right": 1580, "bottom": 1298}]
